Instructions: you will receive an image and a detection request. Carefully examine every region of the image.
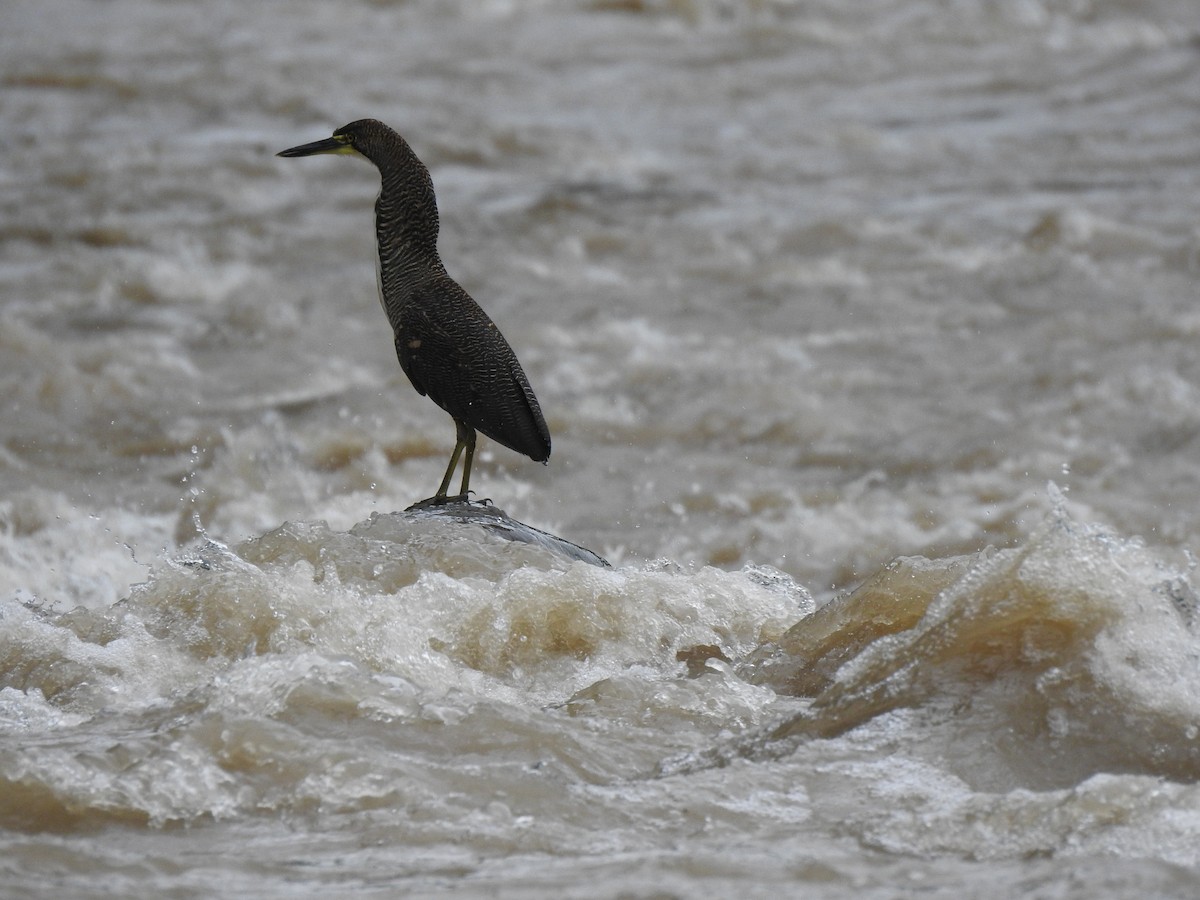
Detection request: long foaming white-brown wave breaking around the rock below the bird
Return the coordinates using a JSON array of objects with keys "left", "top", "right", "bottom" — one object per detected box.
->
[{"left": 0, "top": 514, "right": 811, "bottom": 830}]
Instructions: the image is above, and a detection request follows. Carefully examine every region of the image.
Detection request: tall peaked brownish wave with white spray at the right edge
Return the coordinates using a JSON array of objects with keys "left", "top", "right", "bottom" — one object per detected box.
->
[{"left": 662, "top": 494, "right": 1200, "bottom": 791}]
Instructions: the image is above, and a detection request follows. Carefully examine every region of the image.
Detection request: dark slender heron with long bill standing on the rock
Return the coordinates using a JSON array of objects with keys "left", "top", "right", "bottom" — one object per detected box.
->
[{"left": 276, "top": 119, "right": 550, "bottom": 506}]
